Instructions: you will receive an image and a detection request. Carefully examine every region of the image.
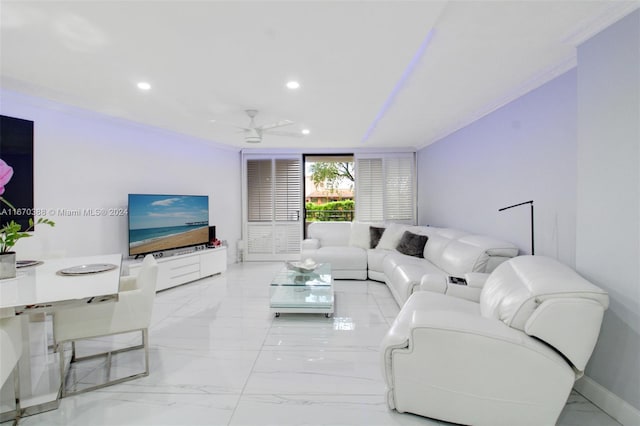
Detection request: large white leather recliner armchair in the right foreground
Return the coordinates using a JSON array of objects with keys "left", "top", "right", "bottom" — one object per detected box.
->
[{"left": 381, "top": 256, "right": 609, "bottom": 426}]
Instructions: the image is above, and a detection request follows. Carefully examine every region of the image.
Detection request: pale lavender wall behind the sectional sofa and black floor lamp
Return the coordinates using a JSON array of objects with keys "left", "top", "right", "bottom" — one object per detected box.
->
[{"left": 418, "top": 69, "right": 576, "bottom": 265}]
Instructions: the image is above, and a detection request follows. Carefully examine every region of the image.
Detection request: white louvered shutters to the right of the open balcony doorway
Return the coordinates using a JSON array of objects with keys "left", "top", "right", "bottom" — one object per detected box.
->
[{"left": 356, "top": 153, "right": 416, "bottom": 224}]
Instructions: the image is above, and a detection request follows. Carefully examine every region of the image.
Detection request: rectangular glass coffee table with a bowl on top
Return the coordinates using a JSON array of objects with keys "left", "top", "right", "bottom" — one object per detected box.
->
[{"left": 270, "top": 263, "right": 334, "bottom": 318}]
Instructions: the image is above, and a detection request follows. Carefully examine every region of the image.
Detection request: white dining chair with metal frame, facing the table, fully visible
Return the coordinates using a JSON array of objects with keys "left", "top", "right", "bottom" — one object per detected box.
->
[{"left": 53, "top": 255, "right": 158, "bottom": 397}]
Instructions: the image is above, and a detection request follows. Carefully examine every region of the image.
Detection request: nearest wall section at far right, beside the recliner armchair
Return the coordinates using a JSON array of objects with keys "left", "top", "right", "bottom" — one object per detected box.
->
[{"left": 576, "top": 11, "right": 640, "bottom": 410}]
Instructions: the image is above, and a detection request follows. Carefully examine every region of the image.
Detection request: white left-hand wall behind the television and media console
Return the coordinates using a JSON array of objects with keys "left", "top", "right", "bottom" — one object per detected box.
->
[{"left": 0, "top": 91, "right": 241, "bottom": 262}]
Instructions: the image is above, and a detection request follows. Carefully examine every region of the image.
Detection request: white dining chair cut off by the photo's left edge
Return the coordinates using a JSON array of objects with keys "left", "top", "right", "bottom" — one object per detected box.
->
[{"left": 0, "top": 317, "right": 22, "bottom": 426}]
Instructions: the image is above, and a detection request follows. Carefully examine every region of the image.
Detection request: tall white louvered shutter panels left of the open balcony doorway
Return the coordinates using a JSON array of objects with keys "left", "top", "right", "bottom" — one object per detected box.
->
[{"left": 244, "top": 155, "right": 303, "bottom": 260}]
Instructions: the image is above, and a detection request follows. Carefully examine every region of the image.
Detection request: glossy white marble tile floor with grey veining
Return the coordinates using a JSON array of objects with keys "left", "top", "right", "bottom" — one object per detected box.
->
[{"left": 3, "top": 263, "right": 619, "bottom": 426}]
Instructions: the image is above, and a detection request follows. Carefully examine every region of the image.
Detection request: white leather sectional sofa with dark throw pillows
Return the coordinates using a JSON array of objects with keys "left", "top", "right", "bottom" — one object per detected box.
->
[{"left": 302, "top": 222, "right": 518, "bottom": 306}]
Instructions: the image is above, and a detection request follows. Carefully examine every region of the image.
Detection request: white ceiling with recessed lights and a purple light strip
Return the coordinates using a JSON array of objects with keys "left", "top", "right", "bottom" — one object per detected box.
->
[{"left": 0, "top": 0, "right": 639, "bottom": 150}]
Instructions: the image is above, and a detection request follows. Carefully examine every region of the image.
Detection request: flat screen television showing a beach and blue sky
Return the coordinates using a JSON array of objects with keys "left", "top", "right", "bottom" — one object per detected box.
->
[{"left": 128, "top": 194, "right": 209, "bottom": 256}]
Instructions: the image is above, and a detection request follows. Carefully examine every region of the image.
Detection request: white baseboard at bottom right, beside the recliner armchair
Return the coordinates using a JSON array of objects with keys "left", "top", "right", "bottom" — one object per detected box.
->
[{"left": 573, "top": 376, "right": 640, "bottom": 426}]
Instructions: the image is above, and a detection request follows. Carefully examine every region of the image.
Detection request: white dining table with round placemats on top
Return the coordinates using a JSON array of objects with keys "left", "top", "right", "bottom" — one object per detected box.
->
[{"left": 0, "top": 253, "right": 122, "bottom": 421}]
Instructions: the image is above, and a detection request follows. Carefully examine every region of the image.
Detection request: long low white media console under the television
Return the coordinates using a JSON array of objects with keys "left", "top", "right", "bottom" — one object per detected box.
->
[{"left": 127, "top": 247, "right": 227, "bottom": 291}]
